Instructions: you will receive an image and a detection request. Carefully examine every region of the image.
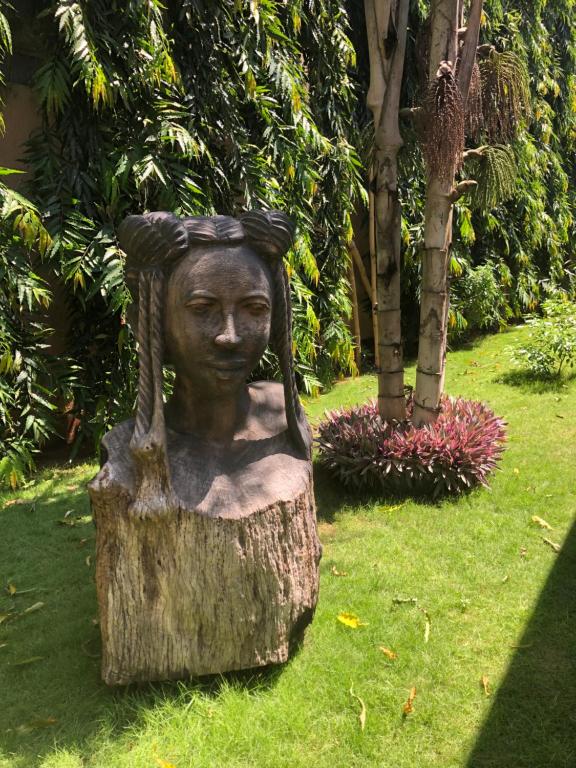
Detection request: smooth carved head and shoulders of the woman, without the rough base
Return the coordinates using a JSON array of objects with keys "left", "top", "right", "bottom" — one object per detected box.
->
[{"left": 99, "top": 212, "right": 311, "bottom": 517}]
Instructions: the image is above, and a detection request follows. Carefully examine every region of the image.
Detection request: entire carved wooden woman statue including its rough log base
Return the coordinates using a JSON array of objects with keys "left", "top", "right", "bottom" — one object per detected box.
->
[{"left": 90, "top": 211, "right": 320, "bottom": 684}]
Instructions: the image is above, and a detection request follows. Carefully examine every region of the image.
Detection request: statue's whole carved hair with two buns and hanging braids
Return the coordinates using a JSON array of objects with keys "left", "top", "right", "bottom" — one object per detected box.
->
[{"left": 118, "top": 211, "right": 310, "bottom": 504}]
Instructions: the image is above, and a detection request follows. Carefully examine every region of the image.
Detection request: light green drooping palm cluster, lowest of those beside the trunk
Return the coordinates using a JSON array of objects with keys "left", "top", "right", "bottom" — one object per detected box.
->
[{"left": 472, "top": 144, "right": 518, "bottom": 211}]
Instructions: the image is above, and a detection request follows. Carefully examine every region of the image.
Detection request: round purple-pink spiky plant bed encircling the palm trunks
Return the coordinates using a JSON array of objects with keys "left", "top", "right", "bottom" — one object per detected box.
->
[{"left": 317, "top": 397, "right": 505, "bottom": 498}]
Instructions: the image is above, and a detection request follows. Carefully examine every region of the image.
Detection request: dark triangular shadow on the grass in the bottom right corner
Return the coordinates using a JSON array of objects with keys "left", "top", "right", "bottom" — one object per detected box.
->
[{"left": 467, "top": 523, "right": 576, "bottom": 768}]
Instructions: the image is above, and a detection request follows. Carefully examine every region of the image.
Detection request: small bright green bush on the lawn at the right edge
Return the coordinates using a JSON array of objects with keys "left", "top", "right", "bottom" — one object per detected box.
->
[{"left": 514, "top": 293, "right": 576, "bottom": 378}]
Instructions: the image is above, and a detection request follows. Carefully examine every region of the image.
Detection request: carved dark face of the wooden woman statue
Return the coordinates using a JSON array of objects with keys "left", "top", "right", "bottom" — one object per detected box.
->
[{"left": 164, "top": 246, "right": 272, "bottom": 399}]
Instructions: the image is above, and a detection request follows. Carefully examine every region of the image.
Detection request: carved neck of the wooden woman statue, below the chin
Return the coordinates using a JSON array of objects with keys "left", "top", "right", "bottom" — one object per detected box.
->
[{"left": 166, "top": 376, "right": 250, "bottom": 443}]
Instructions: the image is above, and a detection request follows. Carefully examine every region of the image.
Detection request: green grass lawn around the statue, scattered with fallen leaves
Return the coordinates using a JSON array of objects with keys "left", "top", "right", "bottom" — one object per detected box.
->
[{"left": 0, "top": 329, "right": 576, "bottom": 768}]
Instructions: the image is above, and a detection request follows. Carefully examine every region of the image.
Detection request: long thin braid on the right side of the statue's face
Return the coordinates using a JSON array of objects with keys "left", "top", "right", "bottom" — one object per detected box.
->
[{"left": 273, "top": 260, "right": 310, "bottom": 456}]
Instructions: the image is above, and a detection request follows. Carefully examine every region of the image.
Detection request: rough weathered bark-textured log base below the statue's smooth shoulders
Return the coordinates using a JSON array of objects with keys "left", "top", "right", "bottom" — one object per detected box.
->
[{"left": 91, "top": 462, "right": 320, "bottom": 685}]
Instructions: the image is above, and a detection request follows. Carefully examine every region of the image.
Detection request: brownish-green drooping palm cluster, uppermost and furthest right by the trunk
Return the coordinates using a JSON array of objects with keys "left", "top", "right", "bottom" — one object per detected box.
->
[{"left": 480, "top": 48, "right": 530, "bottom": 144}]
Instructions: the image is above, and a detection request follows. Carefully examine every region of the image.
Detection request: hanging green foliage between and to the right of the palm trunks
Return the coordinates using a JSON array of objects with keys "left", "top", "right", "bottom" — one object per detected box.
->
[{"left": 350, "top": 0, "right": 576, "bottom": 349}]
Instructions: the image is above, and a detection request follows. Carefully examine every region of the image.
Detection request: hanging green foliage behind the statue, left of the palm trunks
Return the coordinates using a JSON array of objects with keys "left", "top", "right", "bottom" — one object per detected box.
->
[{"left": 0, "top": 0, "right": 363, "bottom": 480}]
